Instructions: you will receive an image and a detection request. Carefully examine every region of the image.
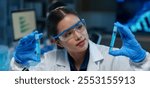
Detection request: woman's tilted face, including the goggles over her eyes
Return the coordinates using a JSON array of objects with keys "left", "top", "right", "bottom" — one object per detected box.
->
[{"left": 57, "top": 14, "right": 89, "bottom": 53}]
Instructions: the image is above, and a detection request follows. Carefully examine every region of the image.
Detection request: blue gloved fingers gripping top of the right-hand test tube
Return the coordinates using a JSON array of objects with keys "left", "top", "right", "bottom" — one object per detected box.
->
[{"left": 114, "top": 22, "right": 134, "bottom": 40}]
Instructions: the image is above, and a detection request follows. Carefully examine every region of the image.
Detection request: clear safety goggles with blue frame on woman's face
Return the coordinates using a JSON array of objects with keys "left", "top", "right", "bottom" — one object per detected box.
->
[{"left": 53, "top": 19, "right": 85, "bottom": 41}]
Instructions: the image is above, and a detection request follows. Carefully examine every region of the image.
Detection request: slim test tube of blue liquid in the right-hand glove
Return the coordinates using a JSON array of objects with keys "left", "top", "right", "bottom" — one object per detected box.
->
[{"left": 109, "top": 26, "right": 117, "bottom": 51}]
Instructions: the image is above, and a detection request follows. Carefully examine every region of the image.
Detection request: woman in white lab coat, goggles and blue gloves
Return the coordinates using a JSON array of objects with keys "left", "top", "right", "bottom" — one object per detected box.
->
[{"left": 11, "top": 2, "right": 150, "bottom": 71}]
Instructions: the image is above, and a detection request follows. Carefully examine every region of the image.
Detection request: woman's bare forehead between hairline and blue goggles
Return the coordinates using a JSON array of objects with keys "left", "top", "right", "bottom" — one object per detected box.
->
[{"left": 57, "top": 14, "right": 80, "bottom": 33}]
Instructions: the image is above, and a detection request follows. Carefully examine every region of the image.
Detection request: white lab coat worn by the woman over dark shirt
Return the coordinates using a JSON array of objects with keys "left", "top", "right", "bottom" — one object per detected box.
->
[{"left": 11, "top": 41, "right": 150, "bottom": 71}]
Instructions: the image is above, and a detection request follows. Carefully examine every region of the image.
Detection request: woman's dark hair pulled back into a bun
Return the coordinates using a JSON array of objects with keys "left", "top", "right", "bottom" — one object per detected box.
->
[{"left": 47, "top": 2, "right": 77, "bottom": 37}]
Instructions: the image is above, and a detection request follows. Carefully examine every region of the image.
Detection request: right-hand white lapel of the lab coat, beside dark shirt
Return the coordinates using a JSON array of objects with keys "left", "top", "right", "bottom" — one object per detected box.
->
[{"left": 87, "top": 41, "right": 104, "bottom": 71}]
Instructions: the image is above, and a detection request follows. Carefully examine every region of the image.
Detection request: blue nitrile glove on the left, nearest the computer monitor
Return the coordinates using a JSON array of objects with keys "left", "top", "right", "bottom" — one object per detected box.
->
[{"left": 14, "top": 31, "right": 43, "bottom": 67}]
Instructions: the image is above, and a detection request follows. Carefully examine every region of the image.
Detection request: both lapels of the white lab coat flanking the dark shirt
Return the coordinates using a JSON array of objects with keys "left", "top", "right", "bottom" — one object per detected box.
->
[{"left": 56, "top": 40, "right": 104, "bottom": 71}]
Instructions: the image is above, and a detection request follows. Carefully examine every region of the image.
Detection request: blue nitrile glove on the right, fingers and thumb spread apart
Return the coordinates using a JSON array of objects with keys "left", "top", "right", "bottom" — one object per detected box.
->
[{"left": 109, "top": 22, "right": 146, "bottom": 63}]
